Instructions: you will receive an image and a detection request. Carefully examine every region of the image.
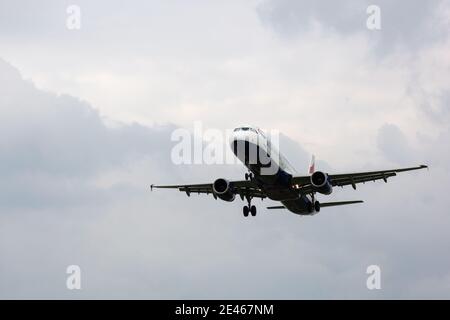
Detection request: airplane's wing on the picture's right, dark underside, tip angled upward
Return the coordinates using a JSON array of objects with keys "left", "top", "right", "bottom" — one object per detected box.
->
[{"left": 292, "top": 165, "right": 428, "bottom": 194}]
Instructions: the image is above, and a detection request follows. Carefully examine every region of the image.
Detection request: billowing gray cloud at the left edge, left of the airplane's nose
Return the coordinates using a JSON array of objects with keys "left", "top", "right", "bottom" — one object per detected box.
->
[{"left": 0, "top": 60, "right": 173, "bottom": 207}]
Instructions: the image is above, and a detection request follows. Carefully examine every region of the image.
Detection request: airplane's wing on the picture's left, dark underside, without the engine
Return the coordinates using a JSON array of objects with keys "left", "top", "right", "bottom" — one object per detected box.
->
[{"left": 150, "top": 180, "right": 266, "bottom": 199}]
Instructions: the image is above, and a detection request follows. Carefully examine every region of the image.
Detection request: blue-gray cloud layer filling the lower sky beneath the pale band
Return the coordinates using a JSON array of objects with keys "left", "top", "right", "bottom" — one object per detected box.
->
[{"left": 0, "top": 19, "right": 450, "bottom": 299}]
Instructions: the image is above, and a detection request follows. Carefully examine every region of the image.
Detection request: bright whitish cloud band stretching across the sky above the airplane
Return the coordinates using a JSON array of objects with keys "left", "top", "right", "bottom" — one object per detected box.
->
[{"left": 0, "top": 1, "right": 449, "bottom": 166}]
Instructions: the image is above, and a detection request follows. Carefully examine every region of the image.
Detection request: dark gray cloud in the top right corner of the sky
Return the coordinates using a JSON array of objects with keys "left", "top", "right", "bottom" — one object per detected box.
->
[{"left": 258, "top": 0, "right": 448, "bottom": 54}]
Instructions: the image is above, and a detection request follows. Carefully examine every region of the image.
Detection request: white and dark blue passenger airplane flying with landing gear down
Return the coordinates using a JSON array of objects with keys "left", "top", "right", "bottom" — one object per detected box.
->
[{"left": 150, "top": 126, "right": 428, "bottom": 217}]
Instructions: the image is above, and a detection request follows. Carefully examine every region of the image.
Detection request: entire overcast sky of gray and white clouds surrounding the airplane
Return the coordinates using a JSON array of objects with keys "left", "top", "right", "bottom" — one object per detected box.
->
[{"left": 0, "top": 0, "right": 450, "bottom": 299}]
